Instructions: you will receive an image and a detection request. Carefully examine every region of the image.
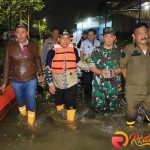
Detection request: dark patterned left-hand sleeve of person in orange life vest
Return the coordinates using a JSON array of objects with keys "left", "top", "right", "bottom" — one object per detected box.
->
[{"left": 45, "top": 50, "right": 55, "bottom": 86}]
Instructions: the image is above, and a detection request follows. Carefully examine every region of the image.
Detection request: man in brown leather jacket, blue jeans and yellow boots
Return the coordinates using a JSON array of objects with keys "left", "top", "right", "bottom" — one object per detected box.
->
[{"left": 0, "top": 25, "right": 42, "bottom": 126}]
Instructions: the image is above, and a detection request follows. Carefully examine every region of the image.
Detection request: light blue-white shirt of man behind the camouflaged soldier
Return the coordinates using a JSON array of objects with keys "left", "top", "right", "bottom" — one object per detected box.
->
[{"left": 80, "top": 39, "right": 100, "bottom": 57}]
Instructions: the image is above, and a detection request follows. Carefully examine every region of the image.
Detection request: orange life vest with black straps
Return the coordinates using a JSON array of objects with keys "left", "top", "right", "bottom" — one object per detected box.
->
[{"left": 51, "top": 44, "right": 77, "bottom": 73}]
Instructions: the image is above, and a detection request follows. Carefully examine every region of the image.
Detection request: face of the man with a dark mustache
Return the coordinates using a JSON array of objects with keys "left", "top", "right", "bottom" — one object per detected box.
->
[{"left": 132, "top": 26, "right": 148, "bottom": 45}]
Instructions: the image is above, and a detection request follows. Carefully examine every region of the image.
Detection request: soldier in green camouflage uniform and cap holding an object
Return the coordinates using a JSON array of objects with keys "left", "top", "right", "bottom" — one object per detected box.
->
[{"left": 90, "top": 27, "right": 121, "bottom": 112}]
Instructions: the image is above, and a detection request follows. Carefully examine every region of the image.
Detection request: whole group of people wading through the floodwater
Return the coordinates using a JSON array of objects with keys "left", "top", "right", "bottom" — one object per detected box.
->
[{"left": 0, "top": 22, "right": 150, "bottom": 126}]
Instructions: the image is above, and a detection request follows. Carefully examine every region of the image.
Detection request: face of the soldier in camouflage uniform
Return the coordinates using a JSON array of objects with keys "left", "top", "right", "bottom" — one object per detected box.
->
[{"left": 103, "top": 34, "right": 116, "bottom": 47}]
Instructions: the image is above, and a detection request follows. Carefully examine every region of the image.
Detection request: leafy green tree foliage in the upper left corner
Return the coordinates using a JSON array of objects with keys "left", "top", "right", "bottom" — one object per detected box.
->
[{"left": 0, "top": 0, "right": 45, "bottom": 30}]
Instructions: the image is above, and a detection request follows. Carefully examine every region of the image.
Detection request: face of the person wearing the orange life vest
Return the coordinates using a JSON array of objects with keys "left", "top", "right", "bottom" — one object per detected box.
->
[{"left": 59, "top": 35, "right": 71, "bottom": 48}]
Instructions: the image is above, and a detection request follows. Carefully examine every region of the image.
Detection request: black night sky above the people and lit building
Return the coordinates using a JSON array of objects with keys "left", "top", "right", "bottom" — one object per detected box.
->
[{"left": 42, "top": 0, "right": 120, "bottom": 29}]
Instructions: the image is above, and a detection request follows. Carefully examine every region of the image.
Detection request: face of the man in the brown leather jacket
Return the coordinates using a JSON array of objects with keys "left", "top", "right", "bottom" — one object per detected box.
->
[{"left": 15, "top": 28, "right": 28, "bottom": 43}]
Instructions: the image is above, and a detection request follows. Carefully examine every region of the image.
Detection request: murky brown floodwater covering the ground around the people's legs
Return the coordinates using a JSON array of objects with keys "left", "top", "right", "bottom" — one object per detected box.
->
[{"left": 0, "top": 86, "right": 150, "bottom": 150}]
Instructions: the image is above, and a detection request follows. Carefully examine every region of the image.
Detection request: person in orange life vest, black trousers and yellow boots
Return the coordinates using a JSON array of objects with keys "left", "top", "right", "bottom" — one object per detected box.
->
[{"left": 46, "top": 31, "right": 89, "bottom": 122}]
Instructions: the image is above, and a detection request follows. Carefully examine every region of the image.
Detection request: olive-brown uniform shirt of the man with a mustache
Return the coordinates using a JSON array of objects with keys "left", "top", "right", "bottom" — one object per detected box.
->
[{"left": 120, "top": 44, "right": 150, "bottom": 89}]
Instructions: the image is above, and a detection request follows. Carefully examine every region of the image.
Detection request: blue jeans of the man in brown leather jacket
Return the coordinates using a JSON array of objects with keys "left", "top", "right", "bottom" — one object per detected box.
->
[{"left": 12, "top": 79, "right": 37, "bottom": 112}]
